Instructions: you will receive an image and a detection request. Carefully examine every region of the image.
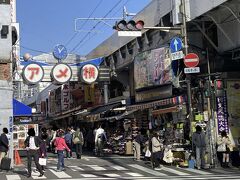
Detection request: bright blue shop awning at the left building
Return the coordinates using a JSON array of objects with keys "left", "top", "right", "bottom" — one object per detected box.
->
[{"left": 13, "top": 99, "right": 32, "bottom": 116}]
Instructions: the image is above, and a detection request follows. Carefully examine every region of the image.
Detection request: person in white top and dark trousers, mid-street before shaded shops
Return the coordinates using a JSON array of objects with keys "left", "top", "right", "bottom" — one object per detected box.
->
[{"left": 95, "top": 125, "right": 107, "bottom": 156}]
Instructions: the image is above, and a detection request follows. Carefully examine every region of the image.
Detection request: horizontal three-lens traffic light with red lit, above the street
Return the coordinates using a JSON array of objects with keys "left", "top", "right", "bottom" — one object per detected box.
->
[{"left": 113, "top": 20, "right": 144, "bottom": 31}]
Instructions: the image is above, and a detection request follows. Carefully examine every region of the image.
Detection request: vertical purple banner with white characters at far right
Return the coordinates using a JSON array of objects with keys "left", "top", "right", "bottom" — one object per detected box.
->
[{"left": 216, "top": 93, "right": 229, "bottom": 134}]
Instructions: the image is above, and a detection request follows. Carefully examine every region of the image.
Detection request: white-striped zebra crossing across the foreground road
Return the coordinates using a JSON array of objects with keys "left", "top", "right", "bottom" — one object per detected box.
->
[{"left": 0, "top": 164, "right": 240, "bottom": 180}]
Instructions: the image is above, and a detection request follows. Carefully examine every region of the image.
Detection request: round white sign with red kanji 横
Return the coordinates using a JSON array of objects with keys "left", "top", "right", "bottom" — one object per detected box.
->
[{"left": 81, "top": 64, "right": 98, "bottom": 84}]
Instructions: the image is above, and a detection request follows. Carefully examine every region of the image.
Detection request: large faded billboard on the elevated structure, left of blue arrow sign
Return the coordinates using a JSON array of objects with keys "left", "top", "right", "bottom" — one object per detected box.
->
[{"left": 134, "top": 47, "right": 173, "bottom": 89}]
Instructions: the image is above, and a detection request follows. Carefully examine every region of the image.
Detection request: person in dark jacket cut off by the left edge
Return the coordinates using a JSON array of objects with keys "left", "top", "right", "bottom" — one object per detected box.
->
[{"left": 0, "top": 128, "right": 9, "bottom": 164}]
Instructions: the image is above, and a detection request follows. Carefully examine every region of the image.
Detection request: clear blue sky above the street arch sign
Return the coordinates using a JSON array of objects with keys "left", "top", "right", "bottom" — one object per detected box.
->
[{"left": 17, "top": 0, "right": 151, "bottom": 56}]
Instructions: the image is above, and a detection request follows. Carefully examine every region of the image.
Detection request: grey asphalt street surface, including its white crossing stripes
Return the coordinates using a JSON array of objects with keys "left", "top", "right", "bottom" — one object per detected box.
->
[{"left": 0, "top": 156, "right": 240, "bottom": 180}]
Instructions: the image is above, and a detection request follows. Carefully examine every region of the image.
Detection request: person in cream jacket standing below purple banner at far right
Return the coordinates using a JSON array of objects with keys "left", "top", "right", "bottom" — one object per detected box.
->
[{"left": 217, "top": 131, "right": 232, "bottom": 168}]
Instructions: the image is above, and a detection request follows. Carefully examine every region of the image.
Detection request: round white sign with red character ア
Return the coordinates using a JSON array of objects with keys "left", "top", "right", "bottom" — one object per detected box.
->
[{"left": 22, "top": 63, "right": 44, "bottom": 84}]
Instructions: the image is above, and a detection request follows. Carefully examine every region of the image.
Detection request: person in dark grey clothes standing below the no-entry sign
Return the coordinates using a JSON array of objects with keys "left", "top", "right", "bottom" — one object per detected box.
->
[{"left": 192, "top": 125, "right": 206, "bottom": 169}]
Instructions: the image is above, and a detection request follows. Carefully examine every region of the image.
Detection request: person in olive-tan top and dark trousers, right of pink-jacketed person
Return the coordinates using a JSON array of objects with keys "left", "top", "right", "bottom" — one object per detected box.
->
[{"left": 73, "top": 128, "right": 84, "bottom": 159}]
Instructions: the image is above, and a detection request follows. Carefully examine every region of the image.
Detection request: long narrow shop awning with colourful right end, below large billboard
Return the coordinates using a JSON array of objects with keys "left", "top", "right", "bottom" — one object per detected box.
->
[{"left": 127, "top": 96, "right": 184, "bottom": 110}]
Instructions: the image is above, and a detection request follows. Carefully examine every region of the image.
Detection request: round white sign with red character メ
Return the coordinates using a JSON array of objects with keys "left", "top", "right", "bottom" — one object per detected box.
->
[{"left": 51, "top": 63, "right": 72, "bottom": 84}]
